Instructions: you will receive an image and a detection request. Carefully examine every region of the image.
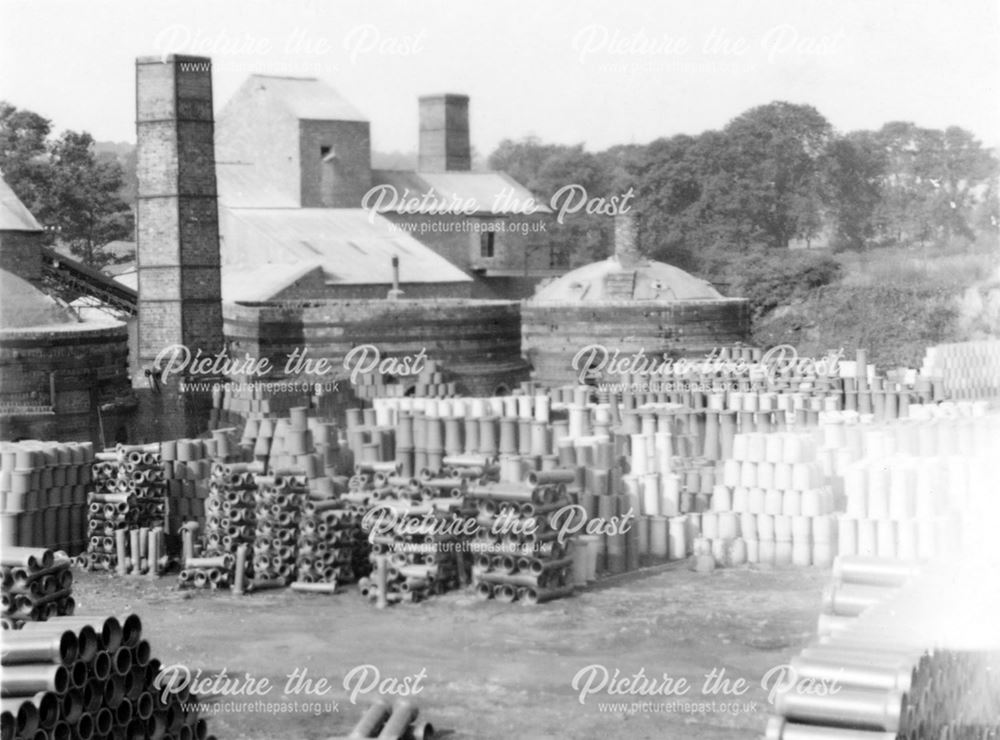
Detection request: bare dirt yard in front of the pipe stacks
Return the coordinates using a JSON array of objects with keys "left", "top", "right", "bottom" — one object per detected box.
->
[{"left": 66, "top": 564, "right": 829, "bottom": 740}]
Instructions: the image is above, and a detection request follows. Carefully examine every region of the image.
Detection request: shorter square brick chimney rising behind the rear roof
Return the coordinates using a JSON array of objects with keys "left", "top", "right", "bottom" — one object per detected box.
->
[{"left": 417, "top": 94, "right": 472, "bottom": 172}]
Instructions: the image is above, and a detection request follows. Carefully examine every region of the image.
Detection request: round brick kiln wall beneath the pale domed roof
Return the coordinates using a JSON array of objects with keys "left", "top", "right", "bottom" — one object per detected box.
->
[{"left": 521, "top": 298, "right": 750, "bottom": 386}]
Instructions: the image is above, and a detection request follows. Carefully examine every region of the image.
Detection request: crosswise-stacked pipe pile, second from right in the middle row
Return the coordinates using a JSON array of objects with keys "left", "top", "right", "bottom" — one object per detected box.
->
[{"left": 355, "top": 458, "right": 468, "bottom": 607}]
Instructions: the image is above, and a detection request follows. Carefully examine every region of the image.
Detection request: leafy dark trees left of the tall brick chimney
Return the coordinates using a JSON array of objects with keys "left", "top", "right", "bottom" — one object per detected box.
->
[{"left": 0, "top": 103, "right": 133, "bottom": 268}]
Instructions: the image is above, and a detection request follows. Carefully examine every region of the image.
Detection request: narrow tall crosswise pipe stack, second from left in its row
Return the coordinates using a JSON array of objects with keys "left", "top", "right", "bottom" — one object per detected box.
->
[{"left": 195, "top": 461, "right": 263, "bottom": 588}]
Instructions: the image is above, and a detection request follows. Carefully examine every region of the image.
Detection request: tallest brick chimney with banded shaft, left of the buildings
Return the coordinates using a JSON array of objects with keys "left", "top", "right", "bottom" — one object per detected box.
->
[{"left": 133, "top": 55, "right": 223, "bottom": 438}]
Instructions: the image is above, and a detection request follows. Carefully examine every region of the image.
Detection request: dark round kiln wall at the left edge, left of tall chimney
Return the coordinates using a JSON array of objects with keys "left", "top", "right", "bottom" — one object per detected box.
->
[{"left": 0, "top": 324, "right": 132, "bottom": 444}]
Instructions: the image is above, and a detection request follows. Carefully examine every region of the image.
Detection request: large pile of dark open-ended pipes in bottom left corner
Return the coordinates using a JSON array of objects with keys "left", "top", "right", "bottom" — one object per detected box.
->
[{"left": 0, "top": 614, "right": 210, "bottom": 739}]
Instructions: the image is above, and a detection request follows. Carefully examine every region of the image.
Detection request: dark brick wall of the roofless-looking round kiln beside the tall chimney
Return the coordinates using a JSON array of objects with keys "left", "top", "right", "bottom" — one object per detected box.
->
[{"left": 223, "top": 300, "right": 528, "bottom": 395}]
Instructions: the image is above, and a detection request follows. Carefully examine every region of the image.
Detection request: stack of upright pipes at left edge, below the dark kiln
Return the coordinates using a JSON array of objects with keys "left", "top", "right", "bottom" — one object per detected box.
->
[{"left": 0, "top": 440, "right": 94, "bottom": 554}]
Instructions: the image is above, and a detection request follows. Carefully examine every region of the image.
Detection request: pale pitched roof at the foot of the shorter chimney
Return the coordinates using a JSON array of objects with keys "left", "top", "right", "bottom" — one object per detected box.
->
[{"left": 372, "top": 170, "right": 551, "bottom": 216}]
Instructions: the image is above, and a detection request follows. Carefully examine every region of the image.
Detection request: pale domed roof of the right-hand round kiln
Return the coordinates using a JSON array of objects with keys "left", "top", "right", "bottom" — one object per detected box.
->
[{"left": 532, "top": 257, "right": 723, "bottom": 303}]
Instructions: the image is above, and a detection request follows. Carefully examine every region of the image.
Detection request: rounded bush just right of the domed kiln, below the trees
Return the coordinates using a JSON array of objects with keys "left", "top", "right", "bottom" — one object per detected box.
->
[{"left": 725, "top": 249, "right": 842, "bottom": 322}]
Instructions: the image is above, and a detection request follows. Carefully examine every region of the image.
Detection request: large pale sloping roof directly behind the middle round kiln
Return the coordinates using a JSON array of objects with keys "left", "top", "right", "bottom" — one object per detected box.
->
[{"left": 221, "top": 207, "right": 472, "bottom": 291}]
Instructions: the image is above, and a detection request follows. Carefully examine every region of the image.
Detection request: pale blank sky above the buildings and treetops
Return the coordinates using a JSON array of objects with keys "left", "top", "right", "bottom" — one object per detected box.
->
[{"left": 0, "top": 0, "right": 1000, "bottom": 154}]
